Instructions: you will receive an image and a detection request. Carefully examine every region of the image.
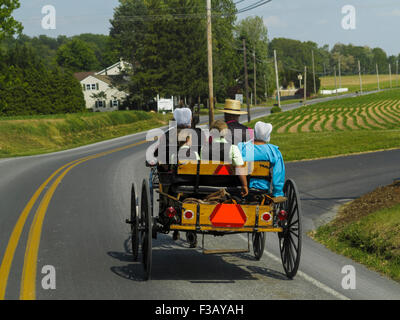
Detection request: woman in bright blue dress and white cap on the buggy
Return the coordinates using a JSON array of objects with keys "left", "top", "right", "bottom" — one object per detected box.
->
[{"left": 239, "top": 121, "right": 285, "bottom": 197}]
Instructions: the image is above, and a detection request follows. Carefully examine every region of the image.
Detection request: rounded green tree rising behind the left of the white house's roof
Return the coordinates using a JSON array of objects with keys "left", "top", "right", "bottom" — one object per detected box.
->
[{"left": 56, "top": 39, "right": 100, "bottom": 72}]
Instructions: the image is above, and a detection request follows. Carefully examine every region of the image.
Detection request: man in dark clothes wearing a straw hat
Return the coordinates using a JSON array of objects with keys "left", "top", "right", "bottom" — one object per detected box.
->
[{"left": 222, "top": 99, "right": 254, "bottom": 145}]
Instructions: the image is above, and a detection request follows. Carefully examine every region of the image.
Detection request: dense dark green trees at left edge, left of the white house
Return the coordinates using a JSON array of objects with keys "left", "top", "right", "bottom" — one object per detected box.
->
[{"left": 0, "top": 45, "right": 85, "bottom": 116}]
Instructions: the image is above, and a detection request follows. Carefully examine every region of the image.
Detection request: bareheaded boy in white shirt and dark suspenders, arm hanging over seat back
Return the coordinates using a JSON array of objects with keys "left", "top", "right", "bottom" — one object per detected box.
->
[{"left": 201, "top": 120, "right": 249, "bottom": 197}]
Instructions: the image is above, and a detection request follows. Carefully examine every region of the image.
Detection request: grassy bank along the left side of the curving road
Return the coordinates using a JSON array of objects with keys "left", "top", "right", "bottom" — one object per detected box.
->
[{"left": 0, "top": 111, "right": 171, "bottom": 158}]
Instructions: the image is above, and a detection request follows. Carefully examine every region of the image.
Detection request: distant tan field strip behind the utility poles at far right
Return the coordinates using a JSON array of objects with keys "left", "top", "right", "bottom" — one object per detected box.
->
[{"left": 321, "top": 74, "right": 400, "bottom": 92}]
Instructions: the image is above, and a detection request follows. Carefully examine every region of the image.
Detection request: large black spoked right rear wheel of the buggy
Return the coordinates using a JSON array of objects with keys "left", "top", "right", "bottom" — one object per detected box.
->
[{"left": 278, "top": 180, "right": 302, "bottom": 279}]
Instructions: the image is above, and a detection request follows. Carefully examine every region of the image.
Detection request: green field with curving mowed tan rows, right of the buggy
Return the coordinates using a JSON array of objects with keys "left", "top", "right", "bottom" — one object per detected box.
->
[{"left": 249, "top": 89, "right": 400, "bottom": 160}]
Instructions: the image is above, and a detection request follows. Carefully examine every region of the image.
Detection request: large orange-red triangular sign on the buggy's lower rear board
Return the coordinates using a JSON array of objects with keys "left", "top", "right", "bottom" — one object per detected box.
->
[{"left": 210, "top": 204, "right": 247, "bottom": 228}]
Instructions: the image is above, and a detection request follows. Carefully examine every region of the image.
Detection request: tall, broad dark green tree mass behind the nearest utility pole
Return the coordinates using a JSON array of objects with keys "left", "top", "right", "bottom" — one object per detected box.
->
[{"left": 110, "top": 0, "right": 236, "bottom": 106}]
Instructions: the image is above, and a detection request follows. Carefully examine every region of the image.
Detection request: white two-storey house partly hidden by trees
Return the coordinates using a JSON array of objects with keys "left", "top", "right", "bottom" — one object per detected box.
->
[{"left": 75, "top": 60, "right": 129, "bottom": 112}]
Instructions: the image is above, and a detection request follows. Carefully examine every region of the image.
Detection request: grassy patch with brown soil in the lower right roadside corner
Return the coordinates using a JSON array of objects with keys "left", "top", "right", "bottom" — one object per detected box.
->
[{"left": 310, "top": 184, "right": 400, "bottom": 282}]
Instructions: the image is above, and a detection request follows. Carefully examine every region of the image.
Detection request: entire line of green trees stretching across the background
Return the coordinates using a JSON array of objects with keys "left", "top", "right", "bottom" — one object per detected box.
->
[{"left": 0, "top": 0, "right": 399, "bottom": 115}]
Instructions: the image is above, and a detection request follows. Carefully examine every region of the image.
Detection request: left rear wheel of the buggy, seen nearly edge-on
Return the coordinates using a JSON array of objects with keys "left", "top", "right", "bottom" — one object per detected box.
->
[{"left": 140, "top": 180, "right": 152, "bottom": 280}]
